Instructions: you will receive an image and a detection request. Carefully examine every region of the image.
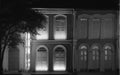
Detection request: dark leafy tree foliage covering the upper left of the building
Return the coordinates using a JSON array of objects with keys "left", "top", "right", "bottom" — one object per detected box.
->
[{"left": 0, "top": 0, "right": 46, "bottom": 72}]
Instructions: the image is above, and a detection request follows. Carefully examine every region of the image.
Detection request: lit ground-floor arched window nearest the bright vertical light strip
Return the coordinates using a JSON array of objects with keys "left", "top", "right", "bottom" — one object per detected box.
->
[{"left": 36, "top": 45, "right": 48, "bottom": 71}]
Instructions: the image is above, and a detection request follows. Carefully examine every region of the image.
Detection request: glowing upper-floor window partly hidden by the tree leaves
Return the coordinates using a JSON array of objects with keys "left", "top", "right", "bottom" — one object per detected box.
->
[{"left": 36, "top": 15, "right": 49, "bottom": 40}]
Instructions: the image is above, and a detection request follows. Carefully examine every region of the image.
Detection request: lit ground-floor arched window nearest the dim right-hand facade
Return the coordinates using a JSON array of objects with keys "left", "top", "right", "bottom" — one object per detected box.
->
[{"left": 53, "top": 45, "right": 66, "bottom": 71}]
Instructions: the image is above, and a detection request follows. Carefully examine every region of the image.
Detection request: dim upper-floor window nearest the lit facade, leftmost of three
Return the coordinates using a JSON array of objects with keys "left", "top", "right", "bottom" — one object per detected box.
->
[{"left": 75, "top": 14, "right": 89, "bottom": 39}]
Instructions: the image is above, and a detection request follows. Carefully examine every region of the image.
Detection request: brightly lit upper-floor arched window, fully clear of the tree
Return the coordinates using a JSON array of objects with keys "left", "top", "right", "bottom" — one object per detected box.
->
[{"left": 54, "top": 15, "right": 67, "bottom": 40}]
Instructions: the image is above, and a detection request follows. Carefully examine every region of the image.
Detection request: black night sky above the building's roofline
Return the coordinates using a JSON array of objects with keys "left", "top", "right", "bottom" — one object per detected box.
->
[{"left": 1, "top": 0, "right": 119, "bottom": 10}]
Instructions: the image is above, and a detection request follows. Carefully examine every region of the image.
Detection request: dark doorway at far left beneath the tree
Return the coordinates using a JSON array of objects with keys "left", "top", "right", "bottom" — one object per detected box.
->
[{"left": 8, "top": 47, "right": 19, "bottom": 71}]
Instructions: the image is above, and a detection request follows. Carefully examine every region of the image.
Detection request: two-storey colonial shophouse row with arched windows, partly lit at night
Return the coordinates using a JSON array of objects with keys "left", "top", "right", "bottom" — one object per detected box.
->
[{"left": 3, "top": 8, "right": 119, "bottom": 74}]
